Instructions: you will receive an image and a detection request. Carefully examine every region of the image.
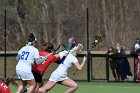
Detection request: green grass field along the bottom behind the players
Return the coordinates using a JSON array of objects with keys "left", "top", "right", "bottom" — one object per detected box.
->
[{"left": 10, "top": 82, "right": 140, "bottom": 93}]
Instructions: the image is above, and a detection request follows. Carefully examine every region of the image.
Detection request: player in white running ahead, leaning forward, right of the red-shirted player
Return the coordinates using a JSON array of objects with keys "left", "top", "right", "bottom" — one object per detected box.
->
[{"left": 39, "top": 44, "right": 86, "bottom": 93}]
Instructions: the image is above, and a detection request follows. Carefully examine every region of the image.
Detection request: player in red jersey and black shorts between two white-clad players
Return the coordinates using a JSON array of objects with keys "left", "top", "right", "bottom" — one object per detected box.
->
[{"left": 32, "top": 42, "right": 66, "bottom": 93}]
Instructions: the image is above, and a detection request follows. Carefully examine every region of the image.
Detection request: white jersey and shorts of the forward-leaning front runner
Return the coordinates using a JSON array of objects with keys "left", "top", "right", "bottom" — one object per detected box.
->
[{"left": 49, "top": 54, "right": 78, "bottom": 82}]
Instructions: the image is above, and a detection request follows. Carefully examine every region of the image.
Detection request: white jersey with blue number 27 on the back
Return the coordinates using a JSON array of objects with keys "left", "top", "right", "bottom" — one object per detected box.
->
[{"left": 16, "top": 45, "right": 39, "bottom": 72}]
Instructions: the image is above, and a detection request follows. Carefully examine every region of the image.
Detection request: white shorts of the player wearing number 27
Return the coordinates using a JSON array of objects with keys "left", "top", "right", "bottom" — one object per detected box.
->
[{"left": 16, "top": 70, "right": 34, "bottom": 80}]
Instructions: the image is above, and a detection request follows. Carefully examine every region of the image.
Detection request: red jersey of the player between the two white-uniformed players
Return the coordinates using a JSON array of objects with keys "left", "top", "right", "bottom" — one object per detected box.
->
[{"left": 32, "top": 51, "right": 57, "bottom": 76}]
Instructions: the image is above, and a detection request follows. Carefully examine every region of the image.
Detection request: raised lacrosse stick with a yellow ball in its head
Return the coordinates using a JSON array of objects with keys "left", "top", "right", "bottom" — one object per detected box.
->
[{"left": 73, "top": 36, "right": 102, "bottom": 75}]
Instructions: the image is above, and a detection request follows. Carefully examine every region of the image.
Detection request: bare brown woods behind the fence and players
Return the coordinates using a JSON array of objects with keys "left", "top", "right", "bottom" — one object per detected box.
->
[{"left": 0, "top": 0, "right": 140, "bottom": 51}]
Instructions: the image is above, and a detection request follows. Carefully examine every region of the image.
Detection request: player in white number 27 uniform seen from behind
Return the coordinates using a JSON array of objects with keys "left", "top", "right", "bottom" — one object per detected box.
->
[{"left": 16, "top": 33, "right": 47, "bottom": 93}]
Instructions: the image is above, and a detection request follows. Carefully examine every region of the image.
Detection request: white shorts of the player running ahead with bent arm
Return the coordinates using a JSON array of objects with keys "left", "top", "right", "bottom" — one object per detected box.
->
[{"left": 49, "top": 71, "right": 68, "bottom": 82}]
